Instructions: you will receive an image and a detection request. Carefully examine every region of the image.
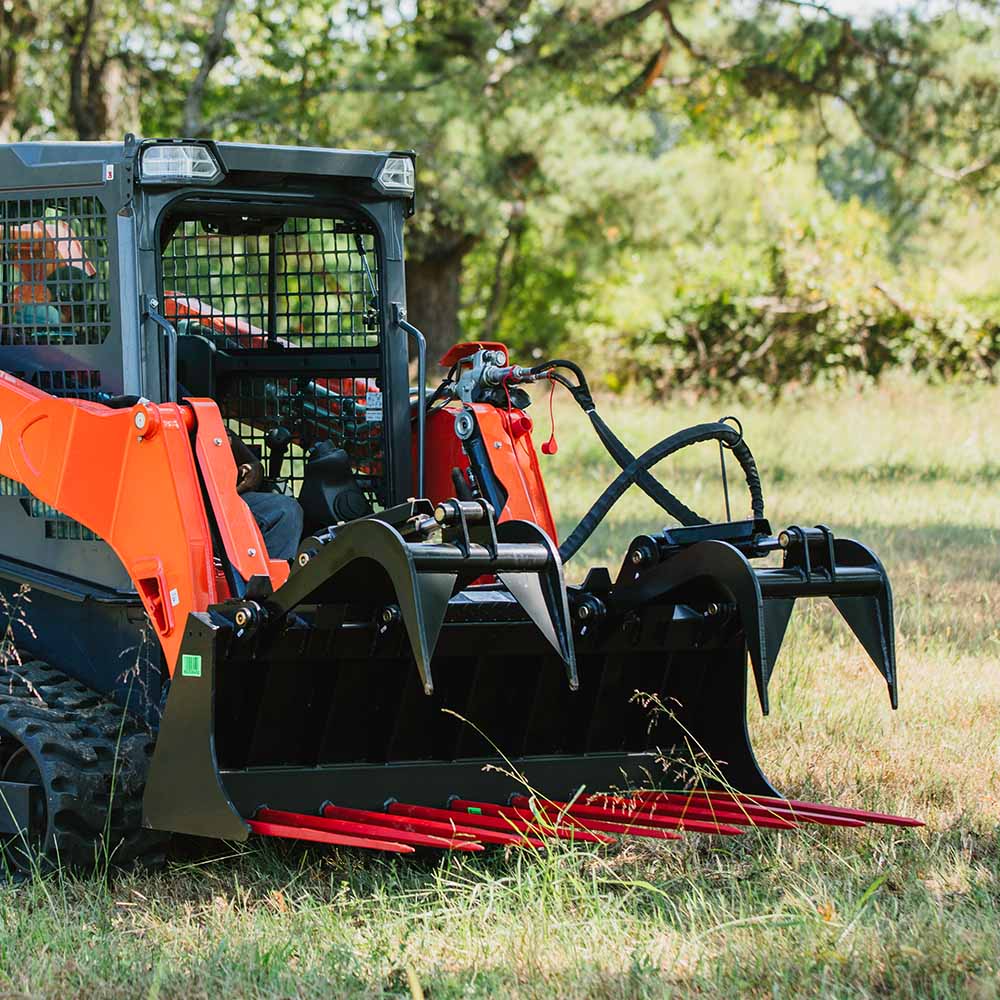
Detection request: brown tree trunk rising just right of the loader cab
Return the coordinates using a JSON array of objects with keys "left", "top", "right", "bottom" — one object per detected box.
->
[{"left": 406, "top": 236, "right": 475, "bottom": 368}]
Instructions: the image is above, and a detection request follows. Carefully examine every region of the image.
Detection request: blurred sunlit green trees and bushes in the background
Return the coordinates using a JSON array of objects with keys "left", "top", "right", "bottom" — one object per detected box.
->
[{"left": 0, "top": 0, "right": 1000, "bottom": 391}]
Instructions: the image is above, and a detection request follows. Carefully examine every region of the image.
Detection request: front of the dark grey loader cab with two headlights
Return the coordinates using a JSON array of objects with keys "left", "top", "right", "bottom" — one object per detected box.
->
[{"left": 137, "top": 143, "right": 413, "bottom": 527}]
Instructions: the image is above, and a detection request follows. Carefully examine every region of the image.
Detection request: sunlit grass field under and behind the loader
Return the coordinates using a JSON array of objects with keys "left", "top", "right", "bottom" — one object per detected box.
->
[{"left": 0, "top": 380, "right": 1000, "bottom": 1000}]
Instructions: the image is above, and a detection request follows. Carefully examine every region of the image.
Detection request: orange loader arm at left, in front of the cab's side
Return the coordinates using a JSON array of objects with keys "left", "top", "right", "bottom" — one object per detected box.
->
[{"left": 0, "top": 372, "right": 288, "bottom": 676}]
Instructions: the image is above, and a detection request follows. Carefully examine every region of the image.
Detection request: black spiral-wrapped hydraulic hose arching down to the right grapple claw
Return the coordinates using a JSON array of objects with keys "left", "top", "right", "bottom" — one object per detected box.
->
[{"left": 559, "top": 423, "right": 764, "bottom": 562}]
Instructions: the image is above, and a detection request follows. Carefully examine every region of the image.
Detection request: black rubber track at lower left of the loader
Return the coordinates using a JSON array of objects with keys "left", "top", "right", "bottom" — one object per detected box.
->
[{"left": 0, "top": 660, "right": 166, "bottom": 870}]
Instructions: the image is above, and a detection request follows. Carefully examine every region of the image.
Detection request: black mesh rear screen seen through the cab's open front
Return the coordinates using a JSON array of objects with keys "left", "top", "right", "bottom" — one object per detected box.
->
[{"left": 162, "top": 217, "right": 385, "bottom": 505}]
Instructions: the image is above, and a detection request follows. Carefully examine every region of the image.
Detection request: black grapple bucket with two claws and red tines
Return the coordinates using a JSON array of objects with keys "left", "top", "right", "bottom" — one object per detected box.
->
[{"left": 145, "top": 501, "right": 916, "bottom": 853}]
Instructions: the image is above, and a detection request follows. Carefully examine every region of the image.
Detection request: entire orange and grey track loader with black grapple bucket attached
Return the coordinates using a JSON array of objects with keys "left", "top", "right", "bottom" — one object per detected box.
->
[{"left": 0, "top": 136, "right": 907, "bottom": 865}]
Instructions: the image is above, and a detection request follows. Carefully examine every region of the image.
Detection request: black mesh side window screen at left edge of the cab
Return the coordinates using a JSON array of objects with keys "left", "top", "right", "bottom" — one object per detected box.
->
[{"left": 0, "top": 196, "right": 111, "bottom": 346}]
